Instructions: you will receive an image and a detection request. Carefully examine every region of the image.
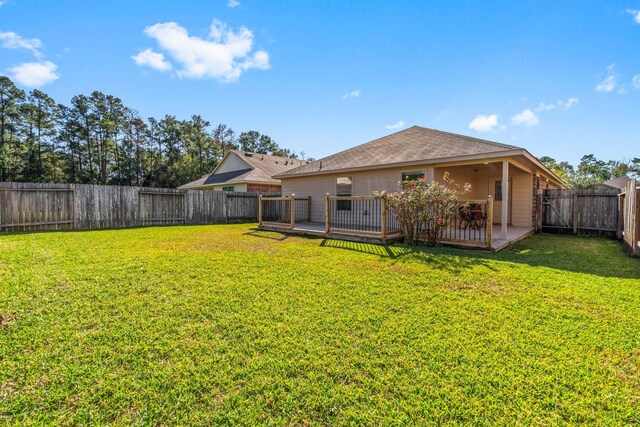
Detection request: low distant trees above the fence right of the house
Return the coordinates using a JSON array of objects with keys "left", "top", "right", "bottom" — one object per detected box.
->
[{"left": 540, "top": 154, "right": 640, "bottom": 188}]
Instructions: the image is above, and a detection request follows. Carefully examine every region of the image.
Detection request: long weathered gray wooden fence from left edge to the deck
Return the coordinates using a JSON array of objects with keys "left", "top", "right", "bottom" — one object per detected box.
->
[{"left": 0, "top": 182, "right": 268, "bottom": 231}]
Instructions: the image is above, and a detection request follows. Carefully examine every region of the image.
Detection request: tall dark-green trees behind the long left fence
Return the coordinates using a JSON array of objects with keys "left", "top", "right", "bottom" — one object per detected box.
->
[{"left": 0, "top": 76, "right": 305, "bottom": 188}]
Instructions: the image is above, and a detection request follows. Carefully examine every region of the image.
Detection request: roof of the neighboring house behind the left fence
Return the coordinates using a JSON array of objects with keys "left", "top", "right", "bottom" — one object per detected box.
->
[{"left": 179, "top": 150, "right": 305, "bottom": 189}]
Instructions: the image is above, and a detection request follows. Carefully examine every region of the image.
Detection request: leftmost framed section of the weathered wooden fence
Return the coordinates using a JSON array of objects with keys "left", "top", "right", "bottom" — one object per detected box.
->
[{"left": 0, "top": 187, "right": 75, "bottom": 231}]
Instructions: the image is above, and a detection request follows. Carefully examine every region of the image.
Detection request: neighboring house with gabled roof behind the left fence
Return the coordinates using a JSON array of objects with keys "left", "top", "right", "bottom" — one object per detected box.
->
[{"left": 178, "top": 150, "right": 306, "bottom": 193}]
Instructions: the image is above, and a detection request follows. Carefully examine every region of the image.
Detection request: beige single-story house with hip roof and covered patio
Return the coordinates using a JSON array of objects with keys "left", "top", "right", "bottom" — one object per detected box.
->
[{"left": 274, "top": 126, "right": 564, "bottom": 249}]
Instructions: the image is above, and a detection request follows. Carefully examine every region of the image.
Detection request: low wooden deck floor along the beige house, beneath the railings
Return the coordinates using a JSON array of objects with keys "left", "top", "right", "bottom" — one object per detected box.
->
[{"left": 260, "top": 222, "right": 534, "bottom": 252}]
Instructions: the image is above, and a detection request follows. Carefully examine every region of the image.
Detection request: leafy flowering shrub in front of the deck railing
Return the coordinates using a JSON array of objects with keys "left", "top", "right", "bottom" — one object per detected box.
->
[{"left": 388, "top": 172, "right": 471, "bottom": 246}]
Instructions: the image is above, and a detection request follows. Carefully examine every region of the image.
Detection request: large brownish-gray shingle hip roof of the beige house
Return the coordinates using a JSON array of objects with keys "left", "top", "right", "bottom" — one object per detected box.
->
[{"left": 276, "top": 126, "right": 520, "bottom": 178}]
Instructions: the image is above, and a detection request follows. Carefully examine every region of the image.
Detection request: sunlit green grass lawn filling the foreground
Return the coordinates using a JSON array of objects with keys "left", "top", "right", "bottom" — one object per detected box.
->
[{"left": 0, "top": 225, "right": 640, "bottom": 426}]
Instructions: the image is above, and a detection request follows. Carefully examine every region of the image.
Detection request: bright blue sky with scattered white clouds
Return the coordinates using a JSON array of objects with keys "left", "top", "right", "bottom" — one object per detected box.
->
[{"left": 0, "top": 0, "right": 640, "bottom": 163}]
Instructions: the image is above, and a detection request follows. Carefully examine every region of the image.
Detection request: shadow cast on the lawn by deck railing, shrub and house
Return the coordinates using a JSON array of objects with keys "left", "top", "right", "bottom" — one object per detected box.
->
[{"left": 320, "top": 234, "right": 640, "bottom": 280}]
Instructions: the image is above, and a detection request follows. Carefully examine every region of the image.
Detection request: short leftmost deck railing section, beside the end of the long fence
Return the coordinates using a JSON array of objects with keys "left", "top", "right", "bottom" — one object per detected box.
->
[{"left": 258, "top": 194, "right": 311, "bottom": 228}]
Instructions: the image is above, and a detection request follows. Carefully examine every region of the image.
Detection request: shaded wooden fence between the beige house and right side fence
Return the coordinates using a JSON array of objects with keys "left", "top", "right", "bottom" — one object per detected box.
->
[{"left": 536, "top": 188, "right": 622, "bottom": 237}]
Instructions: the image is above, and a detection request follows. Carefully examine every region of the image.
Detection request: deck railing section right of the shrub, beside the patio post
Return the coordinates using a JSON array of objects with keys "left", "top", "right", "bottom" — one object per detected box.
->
[{"left": 442, "top": 196, "right": 493, "bottom": 247}]
